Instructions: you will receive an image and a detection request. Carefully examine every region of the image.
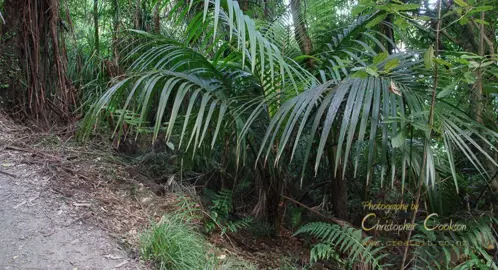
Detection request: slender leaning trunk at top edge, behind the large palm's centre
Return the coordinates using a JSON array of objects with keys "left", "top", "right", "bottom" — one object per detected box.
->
[{"left": 290, "top": 0, "right": 314, "bottom": 69}]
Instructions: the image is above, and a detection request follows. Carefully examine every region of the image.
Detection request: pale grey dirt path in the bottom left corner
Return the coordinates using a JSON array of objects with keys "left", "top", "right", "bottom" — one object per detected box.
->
[{"left": 0, "top": 156, "right": 145, "bottom": 270}]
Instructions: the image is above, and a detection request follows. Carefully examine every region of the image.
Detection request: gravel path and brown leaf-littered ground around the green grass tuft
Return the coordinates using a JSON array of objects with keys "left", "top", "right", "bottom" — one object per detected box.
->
[{"left": 0, "top": 113, "right": 309, "bottom": 270}]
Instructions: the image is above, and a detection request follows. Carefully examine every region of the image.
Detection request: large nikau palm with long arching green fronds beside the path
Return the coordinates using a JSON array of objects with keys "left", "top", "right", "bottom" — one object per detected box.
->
[{"left": 80, "top": 0, "right": 498, "bottom": 266}]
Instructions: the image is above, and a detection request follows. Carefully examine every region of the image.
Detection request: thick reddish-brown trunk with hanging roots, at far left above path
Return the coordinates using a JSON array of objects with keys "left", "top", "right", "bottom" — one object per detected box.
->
[{"left": 0, "top": 0, "right": 75, "bottom": 124}]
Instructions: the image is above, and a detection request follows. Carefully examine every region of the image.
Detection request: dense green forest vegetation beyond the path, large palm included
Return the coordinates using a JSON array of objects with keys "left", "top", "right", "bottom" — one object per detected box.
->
[{"left": 0, "top": 0, "right": 498, "bottom": 269}]
